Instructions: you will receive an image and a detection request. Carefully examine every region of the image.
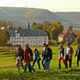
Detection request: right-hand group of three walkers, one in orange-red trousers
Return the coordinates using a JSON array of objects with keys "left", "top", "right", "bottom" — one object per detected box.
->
[{"left": 59, "top": 43, "right": 80, "bottom": 69}]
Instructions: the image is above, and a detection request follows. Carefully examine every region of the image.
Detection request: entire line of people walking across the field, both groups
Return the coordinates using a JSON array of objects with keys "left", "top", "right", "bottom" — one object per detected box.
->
[{"left": 16, "top": 43, "right": 80, "bottom": 72}]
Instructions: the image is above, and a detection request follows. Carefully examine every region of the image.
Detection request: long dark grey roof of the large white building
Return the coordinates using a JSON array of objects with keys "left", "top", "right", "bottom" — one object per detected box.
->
[{"left": 8, "top": 29, "right": 47, "bottom": 37}]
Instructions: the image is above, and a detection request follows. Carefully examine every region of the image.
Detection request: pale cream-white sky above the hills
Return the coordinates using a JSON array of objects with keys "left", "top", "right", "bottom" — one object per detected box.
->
[{"left": 0, "top": 0, "right": 80, "bottom": 12}]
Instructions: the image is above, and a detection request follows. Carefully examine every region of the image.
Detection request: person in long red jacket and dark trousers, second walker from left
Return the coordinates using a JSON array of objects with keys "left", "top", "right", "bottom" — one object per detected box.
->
[{"left": 24, "top": 44, "right": 34, "bottom": 72}]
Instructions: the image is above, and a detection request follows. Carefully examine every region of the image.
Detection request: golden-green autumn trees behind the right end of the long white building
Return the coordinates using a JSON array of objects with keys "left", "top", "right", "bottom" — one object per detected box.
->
[{"left": 32, "top": 21, "right": 63, "bottom": 40}]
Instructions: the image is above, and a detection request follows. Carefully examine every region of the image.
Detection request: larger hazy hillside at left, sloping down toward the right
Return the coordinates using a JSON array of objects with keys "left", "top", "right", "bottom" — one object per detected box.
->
[{"left": 0, "top": 7, "right": 60, "bottom": 25}]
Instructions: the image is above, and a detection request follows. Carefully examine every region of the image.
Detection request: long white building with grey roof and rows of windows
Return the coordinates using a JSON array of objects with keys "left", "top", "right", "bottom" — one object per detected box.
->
[{"left": 8, "top": 28, "right": 48, "bottom": 46}]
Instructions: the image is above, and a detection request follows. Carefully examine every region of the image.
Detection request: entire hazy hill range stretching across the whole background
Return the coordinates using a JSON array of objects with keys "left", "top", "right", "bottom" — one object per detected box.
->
[{"left": 0, "top": 7, "right": 80, "bottom": 26}]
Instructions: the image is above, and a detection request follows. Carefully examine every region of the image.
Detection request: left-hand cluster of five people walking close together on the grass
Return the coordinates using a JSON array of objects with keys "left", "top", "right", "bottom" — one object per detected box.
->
[{"left": 16, "top": 43, "right": 52, "bottom": 72}]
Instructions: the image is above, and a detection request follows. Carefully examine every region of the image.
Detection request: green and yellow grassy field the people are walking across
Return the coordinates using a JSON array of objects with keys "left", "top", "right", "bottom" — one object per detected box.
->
[{"left": 0, "top": 46, "right": 80, "bottom": 80}]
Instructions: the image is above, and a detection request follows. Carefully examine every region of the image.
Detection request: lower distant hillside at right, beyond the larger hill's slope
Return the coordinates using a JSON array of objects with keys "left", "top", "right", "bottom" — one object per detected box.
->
[{"left": 55, "top": 12, "right": 80, "bottom": 24}]
